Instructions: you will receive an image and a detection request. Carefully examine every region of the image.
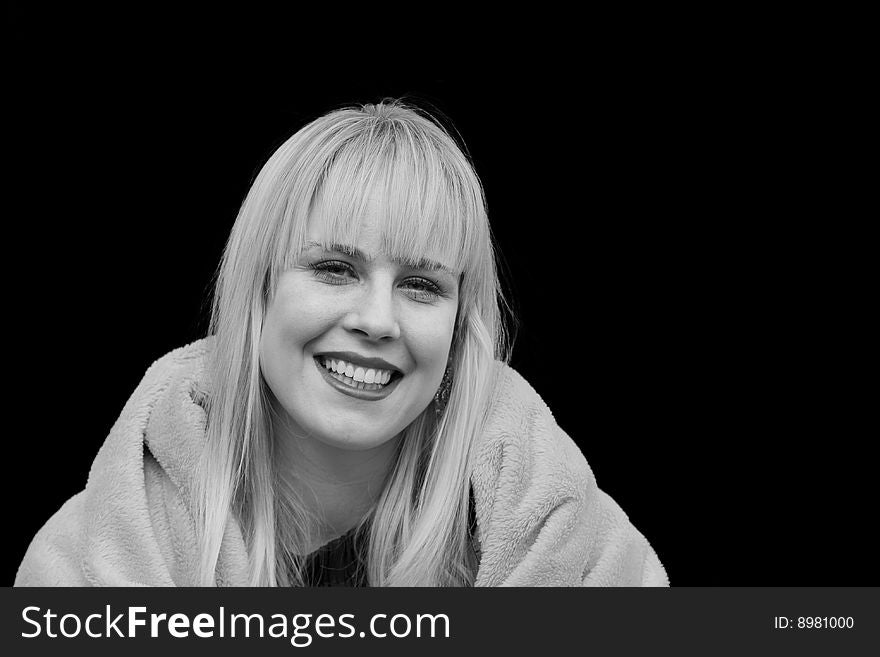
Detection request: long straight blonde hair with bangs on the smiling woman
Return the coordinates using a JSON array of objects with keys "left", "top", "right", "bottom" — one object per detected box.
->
[{"left": 196, "top": 101, "right": 508, "bottom": 586}]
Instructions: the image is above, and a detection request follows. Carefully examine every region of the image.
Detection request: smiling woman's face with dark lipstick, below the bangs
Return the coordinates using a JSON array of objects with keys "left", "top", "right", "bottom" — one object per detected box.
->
[{"left": 260, "top": 197, "right": 458, "bottom": 450}]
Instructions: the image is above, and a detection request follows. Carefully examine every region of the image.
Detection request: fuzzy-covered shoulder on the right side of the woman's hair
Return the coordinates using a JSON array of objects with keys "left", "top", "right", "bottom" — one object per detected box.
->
[{"left": 472, "top": 363, "right": 668, "bottom": 586}]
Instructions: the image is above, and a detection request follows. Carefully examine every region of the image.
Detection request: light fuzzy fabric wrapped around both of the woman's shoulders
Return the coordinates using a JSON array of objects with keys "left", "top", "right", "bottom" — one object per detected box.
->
[{"left": 15, "top": 340, "right": 669, "bottom": 586}]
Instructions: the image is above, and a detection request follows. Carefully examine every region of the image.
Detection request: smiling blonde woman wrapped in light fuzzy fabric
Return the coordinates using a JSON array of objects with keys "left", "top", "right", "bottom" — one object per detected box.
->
[{"left": 16, "top": 102, "right": 667, "bottom": 586}]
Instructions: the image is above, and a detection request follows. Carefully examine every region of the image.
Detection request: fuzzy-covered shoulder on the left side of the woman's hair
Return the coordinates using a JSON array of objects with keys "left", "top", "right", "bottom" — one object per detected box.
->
[{"left": 16, "top": 340, "right": 210, "bottom": 586}]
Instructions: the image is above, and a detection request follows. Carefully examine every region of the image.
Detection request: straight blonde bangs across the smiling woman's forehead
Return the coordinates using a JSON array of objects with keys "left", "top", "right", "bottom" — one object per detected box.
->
[{"left": 291, "top": 122, "right": 487, "bottom": 273}]
